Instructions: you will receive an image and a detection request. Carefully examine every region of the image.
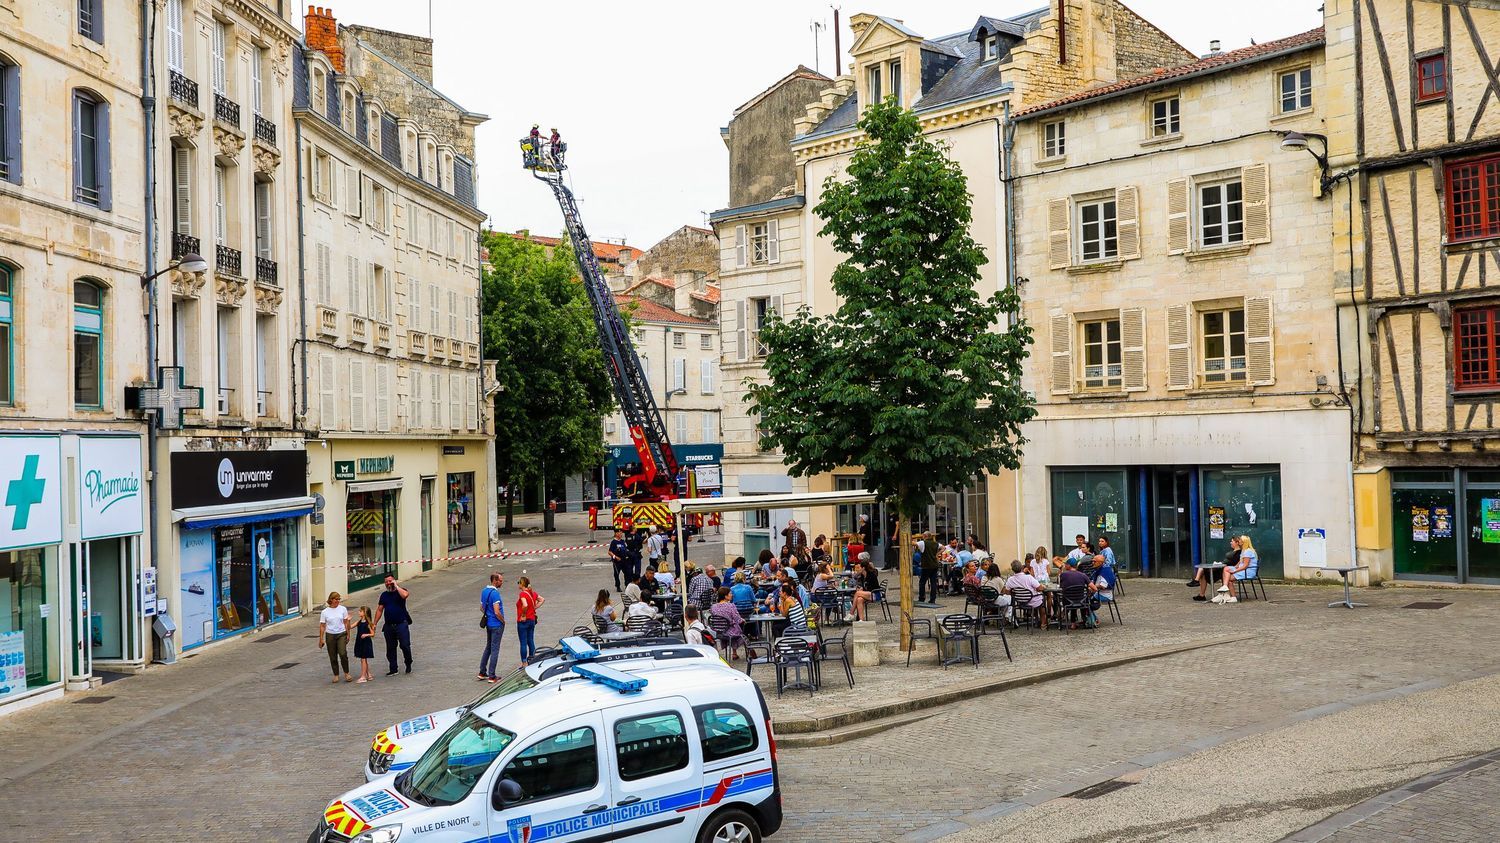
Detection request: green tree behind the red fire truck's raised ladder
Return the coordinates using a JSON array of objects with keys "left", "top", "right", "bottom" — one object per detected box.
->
[{"left": 483, "top": 233, "right": 615, "bottom": 533}]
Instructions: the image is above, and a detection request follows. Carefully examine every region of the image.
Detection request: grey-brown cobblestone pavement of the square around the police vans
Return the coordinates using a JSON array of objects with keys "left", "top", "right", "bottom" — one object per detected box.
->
[{"left": 0, "top": 519, "right": 1500, "bottom": 840}]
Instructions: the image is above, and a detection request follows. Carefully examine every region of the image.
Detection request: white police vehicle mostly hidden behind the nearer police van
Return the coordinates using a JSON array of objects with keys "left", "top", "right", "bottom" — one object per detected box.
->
[{"left": 365, "top": 638, "right": 719, "bottom": 782}]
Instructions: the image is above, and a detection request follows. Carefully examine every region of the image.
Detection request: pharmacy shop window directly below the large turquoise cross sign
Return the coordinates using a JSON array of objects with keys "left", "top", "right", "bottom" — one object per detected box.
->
[{"left": 0, "top": 548, "right": 60, "bottom": 701}]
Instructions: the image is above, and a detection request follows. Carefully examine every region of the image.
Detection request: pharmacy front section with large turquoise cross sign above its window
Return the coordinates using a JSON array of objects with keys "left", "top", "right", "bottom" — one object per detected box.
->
[{"left": 0, "top": 435, "right": 65, "bottom": 708}]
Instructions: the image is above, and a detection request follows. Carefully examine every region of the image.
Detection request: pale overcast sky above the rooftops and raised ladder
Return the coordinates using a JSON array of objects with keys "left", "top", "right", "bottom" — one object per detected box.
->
[{"left": 331, "top": 0, "right": 1323, "bottom": 248}]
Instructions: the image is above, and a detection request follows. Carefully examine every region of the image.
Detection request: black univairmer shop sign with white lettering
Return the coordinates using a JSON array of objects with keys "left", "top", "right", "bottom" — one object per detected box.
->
[{"left": 173, "top": 450, "right": 308, "bottom": 509}]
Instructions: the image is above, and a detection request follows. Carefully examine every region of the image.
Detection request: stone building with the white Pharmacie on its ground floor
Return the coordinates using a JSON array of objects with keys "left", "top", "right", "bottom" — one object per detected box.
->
[{"left": 0, "top": 0, "right": 155, "bottom": 713}]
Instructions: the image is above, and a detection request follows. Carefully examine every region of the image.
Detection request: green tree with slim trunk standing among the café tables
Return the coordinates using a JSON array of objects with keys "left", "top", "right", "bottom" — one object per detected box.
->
[{"left": 747, "top": 101, "right": 1037, "bottom": 648}]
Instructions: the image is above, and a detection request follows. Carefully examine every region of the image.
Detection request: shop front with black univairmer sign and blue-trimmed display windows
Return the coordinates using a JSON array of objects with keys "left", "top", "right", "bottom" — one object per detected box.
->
[{"left": 171, "top": 444, "right": 314, "bottom": 650}]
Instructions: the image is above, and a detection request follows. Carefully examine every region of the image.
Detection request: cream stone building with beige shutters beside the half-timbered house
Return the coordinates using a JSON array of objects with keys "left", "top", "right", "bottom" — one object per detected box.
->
[{"left": 992, "top": 29, "right": 1355, "bottom": 578}]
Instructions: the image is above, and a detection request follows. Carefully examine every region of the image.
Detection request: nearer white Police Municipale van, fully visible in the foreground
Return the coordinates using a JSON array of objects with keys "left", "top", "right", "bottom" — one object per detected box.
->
[{"left": 309, "top": 638, "right": 782, "bottom": 843}]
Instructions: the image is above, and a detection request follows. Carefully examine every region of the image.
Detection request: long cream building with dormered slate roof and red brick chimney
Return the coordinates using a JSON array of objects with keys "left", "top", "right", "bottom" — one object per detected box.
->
[{"left": 294, "top": 8, "right": 495, "bottom": 596}]
